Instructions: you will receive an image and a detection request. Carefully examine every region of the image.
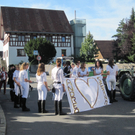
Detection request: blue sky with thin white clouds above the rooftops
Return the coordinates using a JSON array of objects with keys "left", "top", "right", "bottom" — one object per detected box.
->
[{"left": 0, "top": 0, "right": 135, "bottom": 51}]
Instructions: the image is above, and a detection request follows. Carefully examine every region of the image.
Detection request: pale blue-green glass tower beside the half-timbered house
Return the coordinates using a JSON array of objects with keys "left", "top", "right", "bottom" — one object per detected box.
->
[{"left": 70, "top": 19, "right": 86, "bottom": 57}]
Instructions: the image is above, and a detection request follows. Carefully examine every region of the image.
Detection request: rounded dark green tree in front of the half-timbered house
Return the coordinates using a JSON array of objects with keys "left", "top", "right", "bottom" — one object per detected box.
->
[{"left": 24, "top": 38, "right": 56, "bottom": 64}]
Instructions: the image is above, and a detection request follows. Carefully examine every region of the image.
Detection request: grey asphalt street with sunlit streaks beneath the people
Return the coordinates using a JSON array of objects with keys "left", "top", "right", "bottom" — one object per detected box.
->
[{"left": 0, "top": 76, "right": 135, "bottom": 135}]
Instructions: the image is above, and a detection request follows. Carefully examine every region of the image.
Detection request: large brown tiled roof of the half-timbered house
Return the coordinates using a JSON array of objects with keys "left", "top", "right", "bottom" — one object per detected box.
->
[{"left": 1, "top": 7, "right": 73, "bottom": 34}]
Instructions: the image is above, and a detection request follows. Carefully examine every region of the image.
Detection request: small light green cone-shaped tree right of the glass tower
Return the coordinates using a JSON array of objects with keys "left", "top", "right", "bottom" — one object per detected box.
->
[{"left": 80, "top": 32, "right": 99, "bottom": 62}]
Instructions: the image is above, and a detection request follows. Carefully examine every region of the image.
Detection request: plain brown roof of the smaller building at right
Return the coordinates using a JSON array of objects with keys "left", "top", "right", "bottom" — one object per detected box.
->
[{"left": 95, "top": 40, "right": 114, "bottom": 59}]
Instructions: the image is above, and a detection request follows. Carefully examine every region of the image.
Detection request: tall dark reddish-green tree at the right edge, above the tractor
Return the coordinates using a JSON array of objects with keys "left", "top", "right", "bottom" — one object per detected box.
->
[{"left": 113, "top": 8, "right": 135, "bottom": 61}]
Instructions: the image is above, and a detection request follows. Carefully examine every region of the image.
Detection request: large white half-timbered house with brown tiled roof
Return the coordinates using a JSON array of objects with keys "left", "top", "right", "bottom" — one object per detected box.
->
[{"left": 0, "top": 7, "right": 74, "bottom": 66}]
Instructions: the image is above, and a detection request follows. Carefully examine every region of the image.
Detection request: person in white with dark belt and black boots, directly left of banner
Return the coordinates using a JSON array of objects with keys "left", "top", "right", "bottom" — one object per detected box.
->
[{"left": 51, "top": 59, "right": 66, "bottom": 115}]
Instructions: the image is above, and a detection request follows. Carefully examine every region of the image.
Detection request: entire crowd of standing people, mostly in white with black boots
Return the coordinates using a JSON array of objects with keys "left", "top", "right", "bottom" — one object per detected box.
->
[{"left": 0, "top": 59, "right": 118, "bottom": 115}]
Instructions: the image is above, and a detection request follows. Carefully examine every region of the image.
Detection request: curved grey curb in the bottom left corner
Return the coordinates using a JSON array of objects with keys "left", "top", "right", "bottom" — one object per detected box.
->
[{"left": 0, "top": 105, "right": 6, "bottom": 135}]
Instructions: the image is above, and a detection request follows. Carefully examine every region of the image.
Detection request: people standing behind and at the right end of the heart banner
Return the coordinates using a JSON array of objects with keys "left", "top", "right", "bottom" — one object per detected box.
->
[{"left": 63, "top": 58, "right": 119, "bottom": 103}]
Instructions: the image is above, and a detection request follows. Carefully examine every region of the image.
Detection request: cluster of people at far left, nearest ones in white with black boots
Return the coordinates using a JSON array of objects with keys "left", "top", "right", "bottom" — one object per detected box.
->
[{"left": 0, "top": 63, "right": 32, "bottom": 111}]
